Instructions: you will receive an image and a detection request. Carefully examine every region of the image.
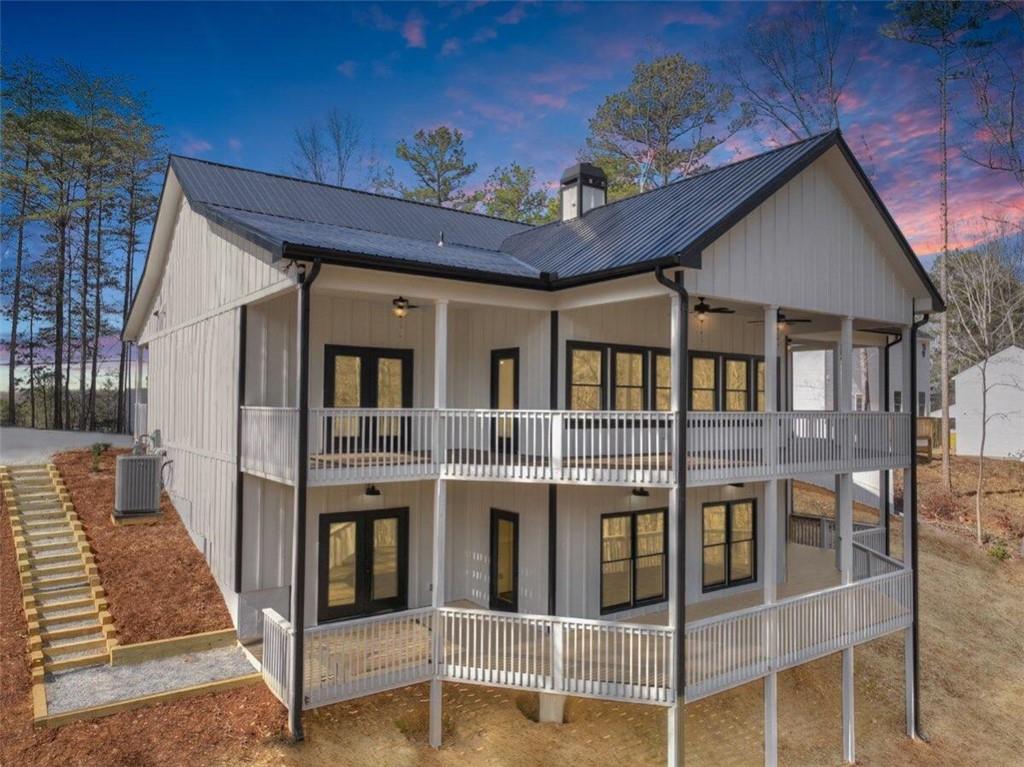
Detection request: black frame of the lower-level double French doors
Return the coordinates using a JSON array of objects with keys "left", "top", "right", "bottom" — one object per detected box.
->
[{"left": 316, "top": 506, "right": 409, "bottom": 623}]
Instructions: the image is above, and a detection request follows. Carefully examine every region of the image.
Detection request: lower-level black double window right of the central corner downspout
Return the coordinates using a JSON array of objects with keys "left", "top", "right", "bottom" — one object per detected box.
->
[{"left": 701, "top": 499, "right": 757, "bottom": 591}]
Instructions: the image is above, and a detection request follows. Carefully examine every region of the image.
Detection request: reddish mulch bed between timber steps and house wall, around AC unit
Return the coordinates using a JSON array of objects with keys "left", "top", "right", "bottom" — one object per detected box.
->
[{"left": 53, "top": 450, "right": 231, "bottom": 644}]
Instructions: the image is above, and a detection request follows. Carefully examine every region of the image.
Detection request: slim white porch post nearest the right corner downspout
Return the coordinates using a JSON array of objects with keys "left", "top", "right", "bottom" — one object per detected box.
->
[{"left": 837, "top": 316, "right": 856, "bottom": 764}]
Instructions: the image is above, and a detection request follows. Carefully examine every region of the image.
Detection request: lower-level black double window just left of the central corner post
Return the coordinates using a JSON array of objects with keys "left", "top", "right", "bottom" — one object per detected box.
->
[{"left": 601, "top": 509, "right": 668, "bottom": 613}]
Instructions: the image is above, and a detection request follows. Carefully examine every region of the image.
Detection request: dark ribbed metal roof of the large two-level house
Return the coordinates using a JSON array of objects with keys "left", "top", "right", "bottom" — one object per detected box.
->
[{"left": 170, "top": 131, "right": 942, "bottom": 310}]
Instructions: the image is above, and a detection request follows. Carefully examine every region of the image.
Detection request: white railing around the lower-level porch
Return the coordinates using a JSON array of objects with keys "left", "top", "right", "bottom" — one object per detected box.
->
[{"left": 263, "top": 557, "right": 912, "bottom": 708}]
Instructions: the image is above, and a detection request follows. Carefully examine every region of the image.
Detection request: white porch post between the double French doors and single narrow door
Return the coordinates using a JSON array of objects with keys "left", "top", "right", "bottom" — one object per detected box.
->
[{"left": 429, "top": 300, "right": 447, "bottom": 749}]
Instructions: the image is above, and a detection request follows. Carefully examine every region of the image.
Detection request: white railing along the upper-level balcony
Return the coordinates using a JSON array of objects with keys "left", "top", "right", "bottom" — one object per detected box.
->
[{"left": 243, "top": 407, "right": 911, "bottom": 486}]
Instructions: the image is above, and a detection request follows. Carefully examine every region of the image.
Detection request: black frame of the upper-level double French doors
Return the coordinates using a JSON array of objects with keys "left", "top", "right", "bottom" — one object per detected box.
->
[{"left": 324, "top": 344, "right": 413, "bottom": 453}]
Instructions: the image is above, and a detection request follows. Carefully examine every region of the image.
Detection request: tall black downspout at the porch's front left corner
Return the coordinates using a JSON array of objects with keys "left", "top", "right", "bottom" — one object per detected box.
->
[{"left": 288, "top": 259, "right": 321, "bottom": 741}]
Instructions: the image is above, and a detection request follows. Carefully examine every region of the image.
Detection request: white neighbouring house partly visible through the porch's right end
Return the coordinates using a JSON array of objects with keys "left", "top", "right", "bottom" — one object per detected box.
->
[{"left": 791, "top": 329, "right": 932, "bottom": 507}]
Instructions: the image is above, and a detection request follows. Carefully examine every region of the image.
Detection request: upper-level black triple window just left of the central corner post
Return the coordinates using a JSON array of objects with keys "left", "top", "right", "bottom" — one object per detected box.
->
[{"left": 565, "top": 341, "right": 672, "bottom": 411}]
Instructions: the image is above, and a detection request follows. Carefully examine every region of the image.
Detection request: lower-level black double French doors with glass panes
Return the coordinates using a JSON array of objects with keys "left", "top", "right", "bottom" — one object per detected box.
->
[{"left": 316, "top": 509, "right": 409, "bottom": 622}]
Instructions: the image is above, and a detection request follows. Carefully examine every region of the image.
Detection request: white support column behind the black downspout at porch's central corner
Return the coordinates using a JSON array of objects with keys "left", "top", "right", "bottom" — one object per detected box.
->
[{"left": 666, "top": 293, "right": 686, "bottom": 767}]
